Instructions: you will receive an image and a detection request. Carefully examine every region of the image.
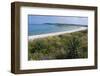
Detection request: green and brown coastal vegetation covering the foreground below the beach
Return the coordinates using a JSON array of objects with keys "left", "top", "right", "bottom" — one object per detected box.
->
[{"left": 28, "top": 30, "right": 88, "bottom": 60}]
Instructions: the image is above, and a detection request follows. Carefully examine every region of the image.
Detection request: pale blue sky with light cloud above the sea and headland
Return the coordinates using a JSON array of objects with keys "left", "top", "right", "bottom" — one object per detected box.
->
[{"left": 28, "top": 15, "right": 88, "bottom": 25}]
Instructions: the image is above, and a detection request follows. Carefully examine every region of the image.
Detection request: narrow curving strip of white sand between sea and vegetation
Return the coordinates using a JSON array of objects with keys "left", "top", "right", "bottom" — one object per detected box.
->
[{"left": 28, "top": 27, "right": 87, "bottom": 40}]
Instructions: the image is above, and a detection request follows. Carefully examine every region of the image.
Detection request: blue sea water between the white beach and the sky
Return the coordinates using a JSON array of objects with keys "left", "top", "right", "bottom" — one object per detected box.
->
[{"left": 28, "top": 24, "right": 82, "bottom": 36}]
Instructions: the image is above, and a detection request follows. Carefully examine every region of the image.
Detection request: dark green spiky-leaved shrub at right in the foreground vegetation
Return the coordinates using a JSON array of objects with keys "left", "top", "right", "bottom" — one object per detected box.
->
[{"left": 66, "top": 37, "right": 81, "bottom": 59}]
